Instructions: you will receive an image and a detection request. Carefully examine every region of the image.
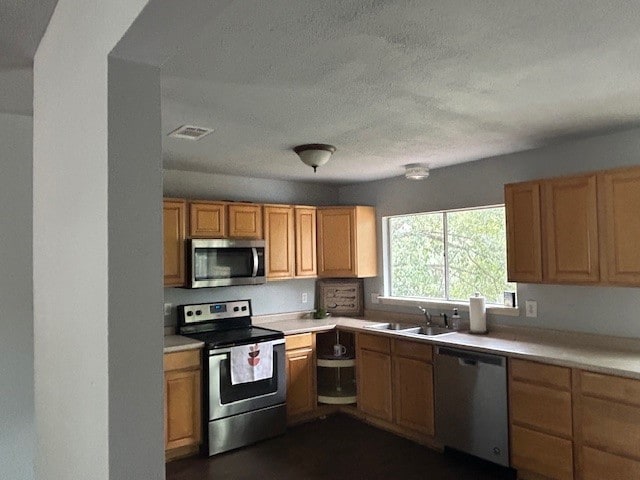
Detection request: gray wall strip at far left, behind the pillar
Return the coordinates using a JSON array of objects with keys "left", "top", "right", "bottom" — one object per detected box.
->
[{"left": 0, "top": 113, "right": 35, "bottom": 480}]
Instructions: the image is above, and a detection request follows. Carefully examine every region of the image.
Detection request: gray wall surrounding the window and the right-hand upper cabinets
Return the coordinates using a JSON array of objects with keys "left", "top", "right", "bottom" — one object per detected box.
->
[{"left": 340, "top": 129, "right": 640, "bottom": 337}]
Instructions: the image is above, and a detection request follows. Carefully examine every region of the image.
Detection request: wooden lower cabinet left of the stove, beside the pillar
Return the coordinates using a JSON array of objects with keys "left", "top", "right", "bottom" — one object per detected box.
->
[{"left": 164, "top": 350, "right": 202, "bottom": 458}]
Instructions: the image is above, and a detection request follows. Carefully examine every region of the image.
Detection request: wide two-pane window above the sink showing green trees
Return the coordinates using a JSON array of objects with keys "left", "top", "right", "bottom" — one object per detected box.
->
[{"left": 385, "top": 206, "right": 515, "bottom": 304}]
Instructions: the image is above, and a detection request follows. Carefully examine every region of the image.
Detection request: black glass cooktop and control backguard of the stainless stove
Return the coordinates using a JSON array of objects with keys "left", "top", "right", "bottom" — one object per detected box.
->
[{"left": 178, "top": 300, "right": 284, "bottom": 349}]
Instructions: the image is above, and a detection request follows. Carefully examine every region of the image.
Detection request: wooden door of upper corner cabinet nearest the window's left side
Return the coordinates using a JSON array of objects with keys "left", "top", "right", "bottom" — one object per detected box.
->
[{"left": 318, "top": 208, "right": 357, "bottom": 277}]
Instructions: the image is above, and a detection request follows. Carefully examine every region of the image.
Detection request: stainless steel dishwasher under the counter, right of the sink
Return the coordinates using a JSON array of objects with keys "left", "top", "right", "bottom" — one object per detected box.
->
[{"left": 435, "top": 347, "right": 509, "bottom": 466}]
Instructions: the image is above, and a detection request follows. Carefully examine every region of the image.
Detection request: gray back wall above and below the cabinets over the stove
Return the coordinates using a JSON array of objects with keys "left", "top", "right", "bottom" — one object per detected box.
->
[{"left": 164, "top": 170, "right": 338, "bottom": 326}]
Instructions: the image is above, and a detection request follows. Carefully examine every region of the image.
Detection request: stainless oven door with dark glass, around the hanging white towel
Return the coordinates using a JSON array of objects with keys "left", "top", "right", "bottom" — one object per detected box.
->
[{"left": 208, "top": 339, "right": 287, "bottom": 420}]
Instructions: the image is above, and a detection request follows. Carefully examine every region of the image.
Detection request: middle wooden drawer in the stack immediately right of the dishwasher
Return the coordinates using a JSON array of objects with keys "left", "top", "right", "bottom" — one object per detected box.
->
[{"left": 509, "top": 380, "right": 573, "bottom": 438}]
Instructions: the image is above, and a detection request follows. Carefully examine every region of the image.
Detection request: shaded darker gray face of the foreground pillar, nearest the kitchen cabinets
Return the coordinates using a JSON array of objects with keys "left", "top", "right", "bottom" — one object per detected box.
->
[{"left": 108, "top": 58, "right": 164, "bottom": 479}]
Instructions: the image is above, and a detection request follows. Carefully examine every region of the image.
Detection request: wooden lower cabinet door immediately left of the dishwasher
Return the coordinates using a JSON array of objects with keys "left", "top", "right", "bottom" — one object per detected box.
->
[{"left": 393, "top": 356, "right": 434, "bottom": 436}]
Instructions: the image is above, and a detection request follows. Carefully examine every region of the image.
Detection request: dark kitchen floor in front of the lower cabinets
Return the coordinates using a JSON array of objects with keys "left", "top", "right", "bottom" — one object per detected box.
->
[{"left": 167, "top": 415, "right": 515, "bottom": 480}]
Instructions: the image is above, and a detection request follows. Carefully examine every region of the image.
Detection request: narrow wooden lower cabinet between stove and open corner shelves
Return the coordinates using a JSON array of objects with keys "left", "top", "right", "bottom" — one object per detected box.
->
[{"left": 285, "top": 333, "right": 316, "bottom": 421}]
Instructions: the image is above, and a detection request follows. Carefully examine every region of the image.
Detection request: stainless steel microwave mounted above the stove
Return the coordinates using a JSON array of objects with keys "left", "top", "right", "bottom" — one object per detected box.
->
[{"left": 188, "top": 239, "right": 265, "bottom": 288}]
